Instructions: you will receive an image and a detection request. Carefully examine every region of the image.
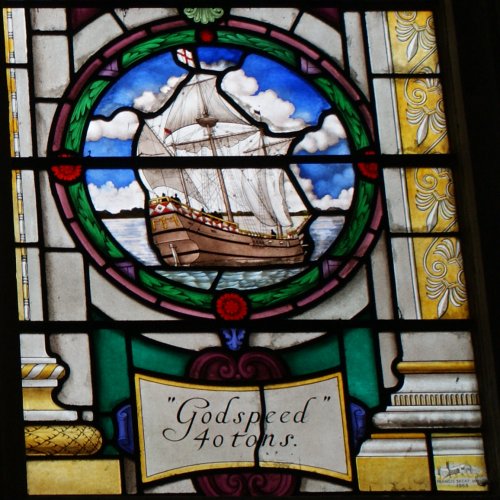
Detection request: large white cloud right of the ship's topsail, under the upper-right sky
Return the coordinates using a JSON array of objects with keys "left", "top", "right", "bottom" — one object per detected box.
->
[{"left": 222, "top": 69, "right": 307, "bottom": 132}]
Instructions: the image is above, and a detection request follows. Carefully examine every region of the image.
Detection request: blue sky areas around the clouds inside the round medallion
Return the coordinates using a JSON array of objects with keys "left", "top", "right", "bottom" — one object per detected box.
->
[{"left": 84, "top": 47, "right": 354, "bottom": 198}]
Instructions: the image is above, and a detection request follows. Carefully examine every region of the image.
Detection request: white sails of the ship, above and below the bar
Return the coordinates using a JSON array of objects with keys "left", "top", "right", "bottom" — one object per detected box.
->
[{"left": 137, "top": 73, "right": 304, "bottom": 236}]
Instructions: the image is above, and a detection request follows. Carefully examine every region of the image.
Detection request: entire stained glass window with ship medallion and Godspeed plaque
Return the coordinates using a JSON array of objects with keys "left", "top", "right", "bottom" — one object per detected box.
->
[{"left": 3, "top": 2, "right": 498, "bottom": 496}]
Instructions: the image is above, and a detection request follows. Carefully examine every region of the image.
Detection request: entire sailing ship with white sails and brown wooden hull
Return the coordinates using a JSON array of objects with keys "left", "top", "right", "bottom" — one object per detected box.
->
[{"left": 137, "top": 73, "right": 307, "bottom": 267}]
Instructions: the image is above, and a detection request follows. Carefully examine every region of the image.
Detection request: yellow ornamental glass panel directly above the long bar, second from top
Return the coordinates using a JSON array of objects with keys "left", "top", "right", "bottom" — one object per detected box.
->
[{"left": 395, "top": 77, "right": 449, "bottom": 154}]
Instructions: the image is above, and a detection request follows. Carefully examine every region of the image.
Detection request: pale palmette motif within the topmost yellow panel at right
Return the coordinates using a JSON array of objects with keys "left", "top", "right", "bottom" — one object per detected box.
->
[{"left": 396, "top": 11, "right": 436, "bottom": 61}]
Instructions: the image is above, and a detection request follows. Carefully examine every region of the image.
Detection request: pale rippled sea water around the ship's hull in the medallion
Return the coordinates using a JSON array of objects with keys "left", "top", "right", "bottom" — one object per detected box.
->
[{"left": 103, "top": 216, "right": 345, "bottom": 290}]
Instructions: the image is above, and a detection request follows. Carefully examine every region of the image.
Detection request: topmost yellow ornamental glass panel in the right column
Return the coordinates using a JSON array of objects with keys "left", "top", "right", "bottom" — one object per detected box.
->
[{"left": 387, "top": 11, "right": 439, "bottom": 73}]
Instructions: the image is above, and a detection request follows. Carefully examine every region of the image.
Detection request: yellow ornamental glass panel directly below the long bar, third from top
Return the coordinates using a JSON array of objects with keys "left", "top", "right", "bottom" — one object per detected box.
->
[{"left": 406, "top": 168, "right": 458, "bottom": 232}]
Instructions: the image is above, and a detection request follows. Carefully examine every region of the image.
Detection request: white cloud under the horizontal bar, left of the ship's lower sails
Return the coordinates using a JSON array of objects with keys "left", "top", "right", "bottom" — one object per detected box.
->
[{"left": 89, "top": 181, "right": 144, "bottom": 214}]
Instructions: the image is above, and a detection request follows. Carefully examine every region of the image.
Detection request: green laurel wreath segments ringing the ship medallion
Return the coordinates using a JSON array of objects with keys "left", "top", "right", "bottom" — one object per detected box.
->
[{"left": 64, "top": 29, "right": 377, "bottom": 312}]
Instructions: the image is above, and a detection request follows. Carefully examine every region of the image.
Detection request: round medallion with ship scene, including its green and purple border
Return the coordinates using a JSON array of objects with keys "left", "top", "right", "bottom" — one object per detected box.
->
[{"left": 50, "top": 19, "right": 382, "bottom": 321}]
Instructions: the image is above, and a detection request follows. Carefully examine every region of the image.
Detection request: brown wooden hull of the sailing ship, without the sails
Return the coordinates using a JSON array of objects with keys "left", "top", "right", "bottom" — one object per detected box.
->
[{"left": 151, "top": 212, "right": 304, "bottom": 267}]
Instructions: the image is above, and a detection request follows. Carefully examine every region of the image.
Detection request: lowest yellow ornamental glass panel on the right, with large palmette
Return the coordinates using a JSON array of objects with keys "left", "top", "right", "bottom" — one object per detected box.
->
[{"left": 413, "top": 237, "right": 469, "bottom": 319}]
